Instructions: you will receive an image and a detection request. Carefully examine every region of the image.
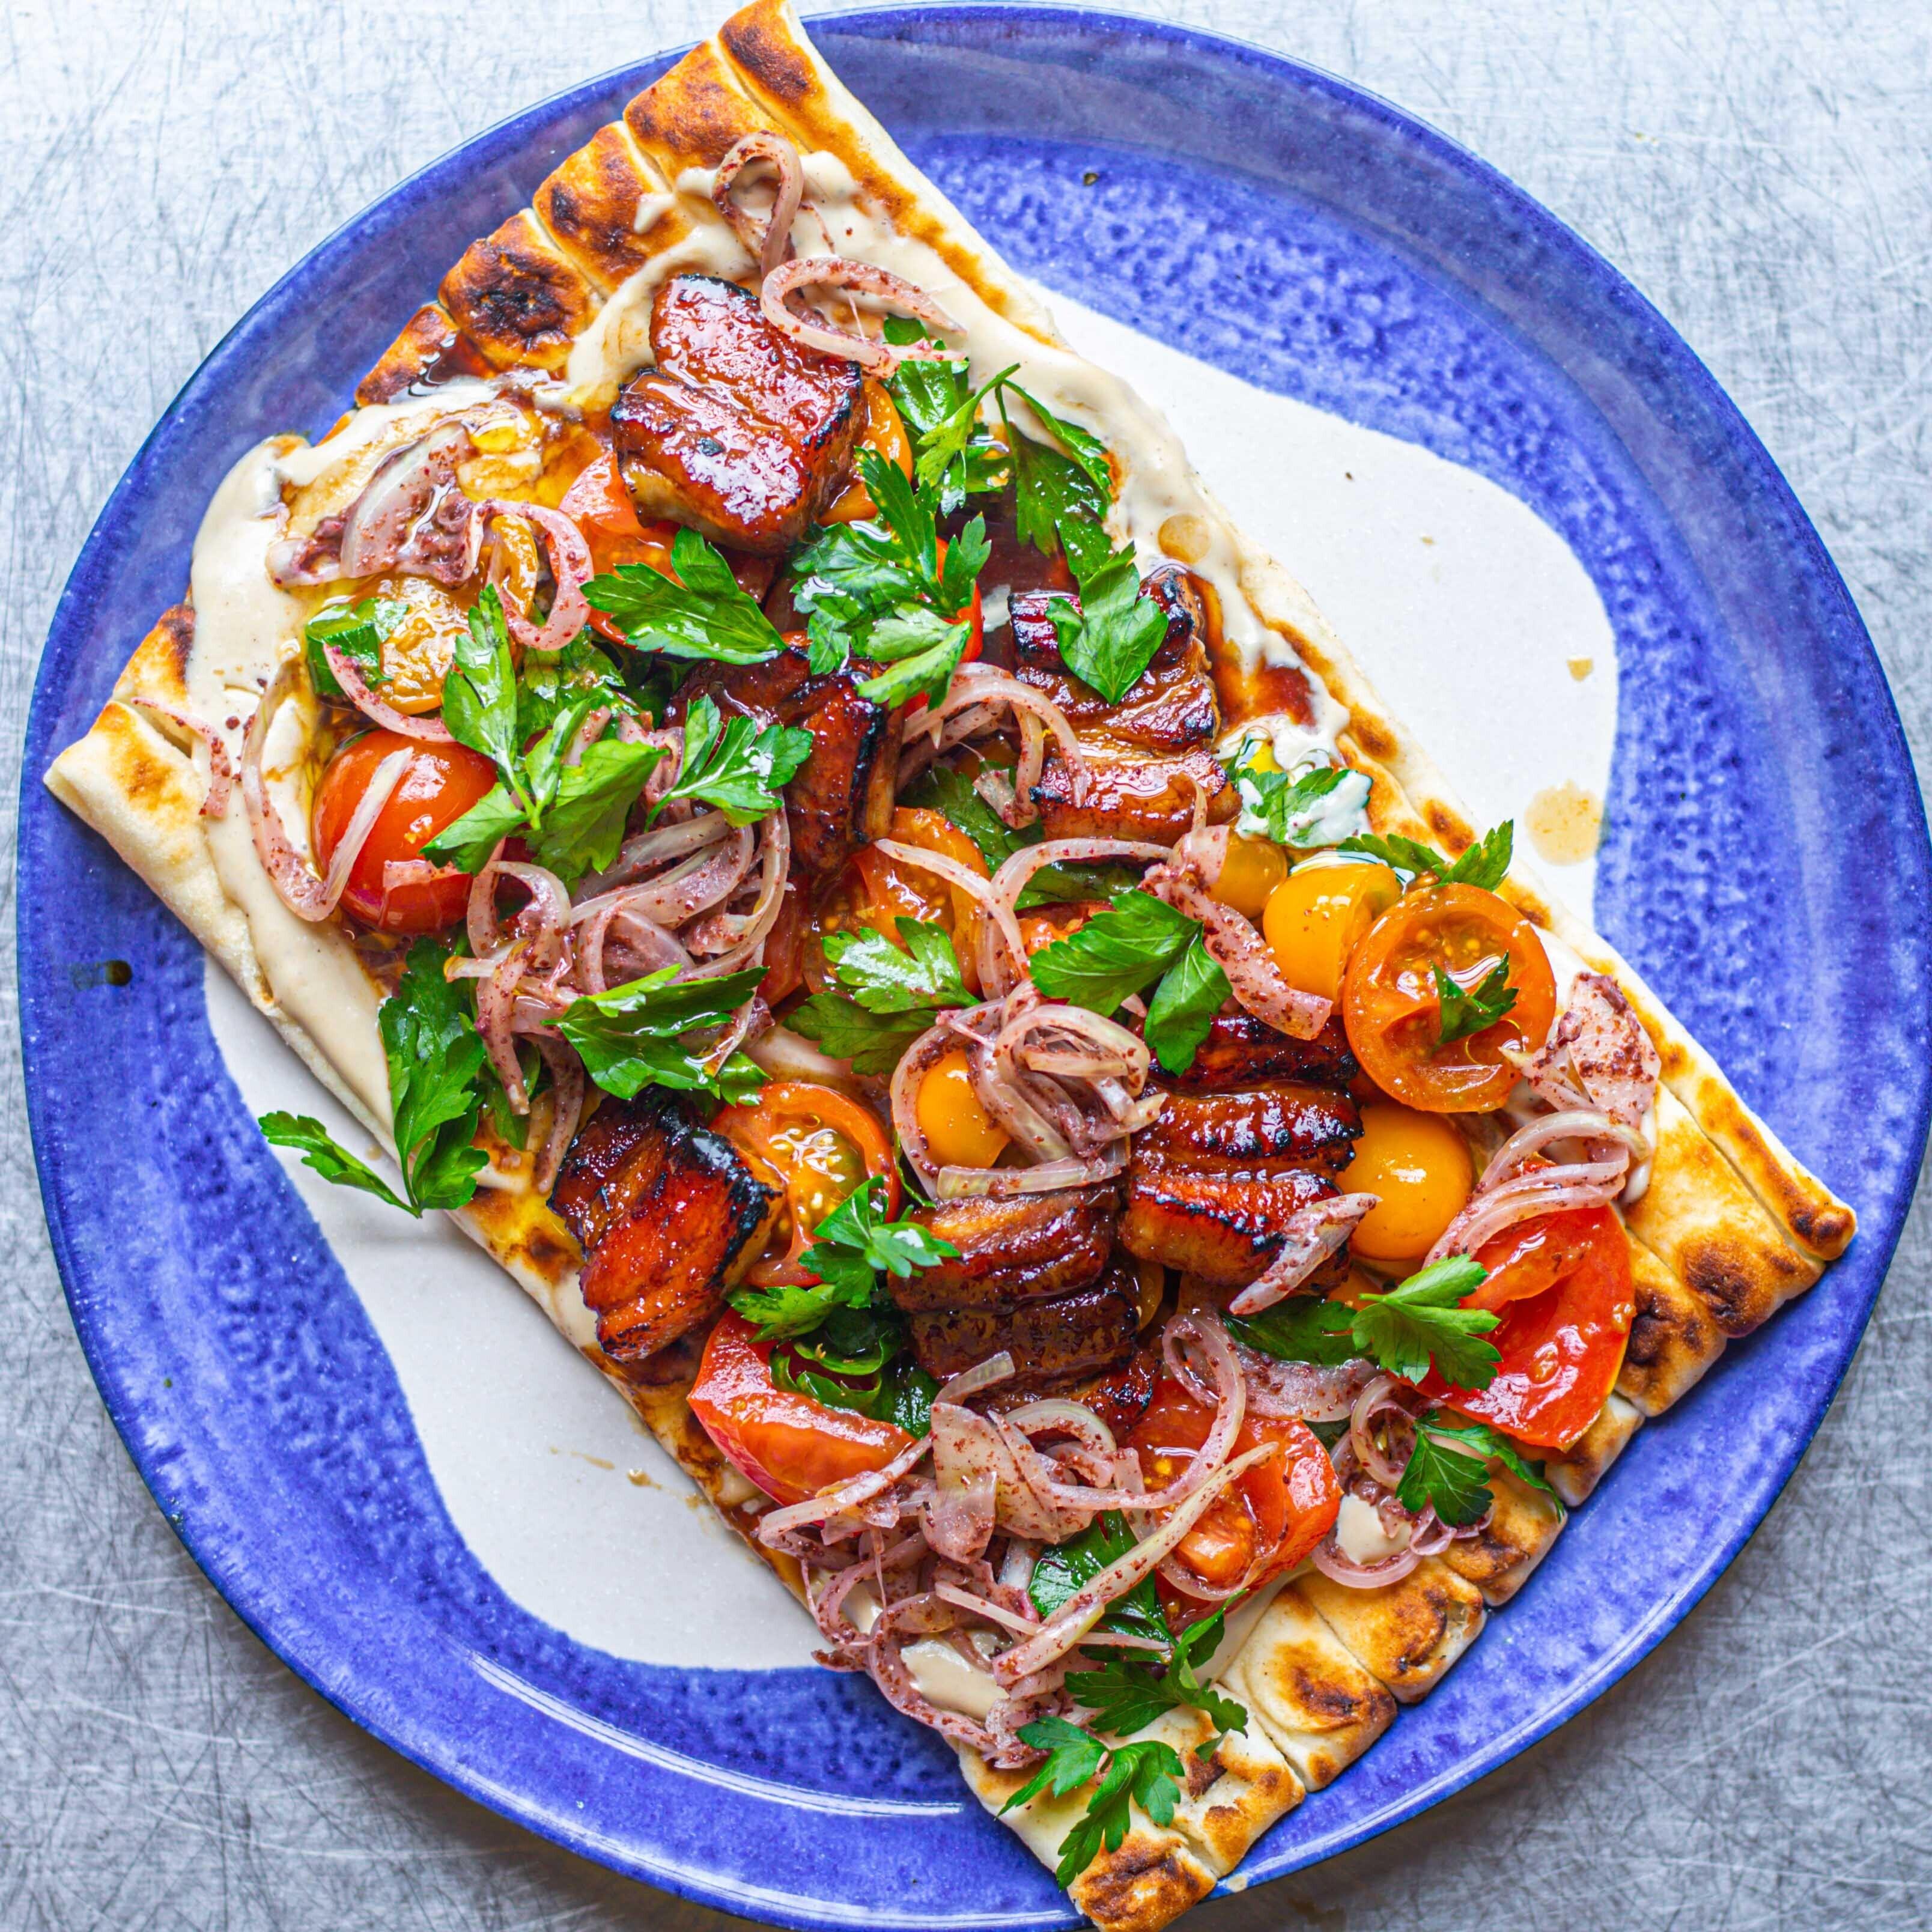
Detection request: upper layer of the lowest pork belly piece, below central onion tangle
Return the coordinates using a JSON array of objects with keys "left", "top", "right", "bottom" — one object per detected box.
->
[{"left": 887, "top": 1184, "right": 1120, "bottom": 1314}]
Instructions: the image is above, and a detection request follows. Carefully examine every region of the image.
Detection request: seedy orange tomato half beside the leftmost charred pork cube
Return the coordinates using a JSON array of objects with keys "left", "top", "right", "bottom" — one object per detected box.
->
[{"left": 711, "top": 1080, "right": 898, "bottom": 1289}]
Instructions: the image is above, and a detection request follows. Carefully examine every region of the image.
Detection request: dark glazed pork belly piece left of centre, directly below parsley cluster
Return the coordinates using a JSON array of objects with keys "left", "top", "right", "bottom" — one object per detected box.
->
[{"left": 670, "top": 651, "right": 901, "bottom": 889}]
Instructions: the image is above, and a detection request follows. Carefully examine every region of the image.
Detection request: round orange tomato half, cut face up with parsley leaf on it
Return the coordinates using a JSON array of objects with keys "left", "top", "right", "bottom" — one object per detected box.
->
[{"left": 1341, "top": 885, "right": 1557, "bottom": 1113}]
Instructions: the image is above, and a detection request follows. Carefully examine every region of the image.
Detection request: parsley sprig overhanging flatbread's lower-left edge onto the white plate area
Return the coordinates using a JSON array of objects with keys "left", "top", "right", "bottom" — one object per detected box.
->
[{"left": 261, "top": 939, "right": 489, "bottom": 1219}]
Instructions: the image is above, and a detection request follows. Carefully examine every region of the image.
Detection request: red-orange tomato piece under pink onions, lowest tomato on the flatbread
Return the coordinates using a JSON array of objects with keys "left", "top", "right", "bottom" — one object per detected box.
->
[{"left": 1126, "top": 1378, "right": 1341, "bottom": 1621}]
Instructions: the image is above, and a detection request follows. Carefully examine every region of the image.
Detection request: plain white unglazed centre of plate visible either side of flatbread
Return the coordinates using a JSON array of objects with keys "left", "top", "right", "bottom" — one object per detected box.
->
[{"left": 207, "top": 309, "right": 1615, "bottom": 1669}]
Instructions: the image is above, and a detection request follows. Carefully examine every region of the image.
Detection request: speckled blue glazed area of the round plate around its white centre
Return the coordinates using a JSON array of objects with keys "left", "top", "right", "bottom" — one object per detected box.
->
[{"left": 19, "top": 6, "right": 1932, "bottom": 1928}]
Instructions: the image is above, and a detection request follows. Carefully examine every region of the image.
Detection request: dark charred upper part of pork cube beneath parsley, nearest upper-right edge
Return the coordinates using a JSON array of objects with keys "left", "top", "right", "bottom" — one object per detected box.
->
[{"left": 1010, "top": 564, "right": 1221, "bottom": 753}]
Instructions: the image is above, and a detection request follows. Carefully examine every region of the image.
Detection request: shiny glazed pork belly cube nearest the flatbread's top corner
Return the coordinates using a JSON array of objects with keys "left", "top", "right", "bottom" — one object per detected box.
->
[{"left": 610, "top": 275, "right": 864, "bottom": 556}]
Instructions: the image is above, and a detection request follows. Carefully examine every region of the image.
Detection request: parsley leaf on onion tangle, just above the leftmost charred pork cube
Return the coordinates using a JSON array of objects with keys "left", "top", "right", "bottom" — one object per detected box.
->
[{"left": 556, "top": 966, "right": 765, "bottom": 1103}]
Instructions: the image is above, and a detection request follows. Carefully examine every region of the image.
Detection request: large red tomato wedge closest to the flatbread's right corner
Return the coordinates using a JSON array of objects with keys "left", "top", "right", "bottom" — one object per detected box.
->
[{"left": 1422, "top": 1208, "right": 1636, "bottom": 1449}]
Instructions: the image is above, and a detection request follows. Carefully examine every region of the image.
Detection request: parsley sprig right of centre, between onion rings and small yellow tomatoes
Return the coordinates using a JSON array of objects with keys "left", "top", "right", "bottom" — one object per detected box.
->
[{"left": 1030, "top": 889, "right": 1229, "bottom": 1072}]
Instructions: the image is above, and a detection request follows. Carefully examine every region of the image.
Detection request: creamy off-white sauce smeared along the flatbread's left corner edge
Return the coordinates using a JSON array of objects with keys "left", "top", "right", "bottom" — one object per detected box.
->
[{"left": 187, "top": 439, "right": 390, "bottom": 1144}]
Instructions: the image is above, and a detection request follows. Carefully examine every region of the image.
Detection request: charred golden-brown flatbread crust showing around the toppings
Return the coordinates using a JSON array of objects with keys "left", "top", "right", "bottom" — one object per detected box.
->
[{"left": 46, "top": 0, "right": 1855, "bottom": 1932}]
